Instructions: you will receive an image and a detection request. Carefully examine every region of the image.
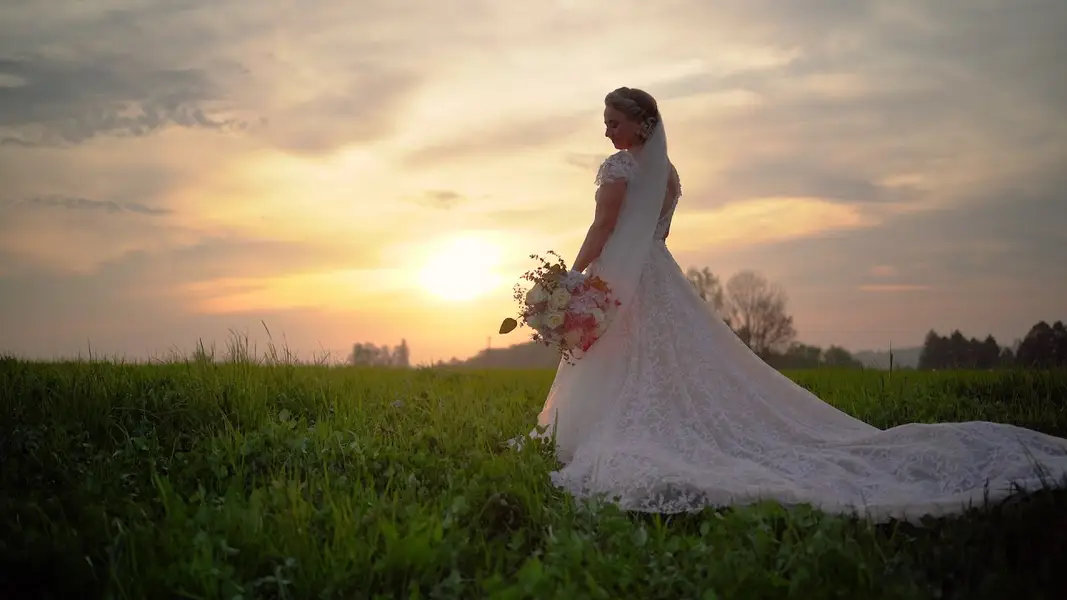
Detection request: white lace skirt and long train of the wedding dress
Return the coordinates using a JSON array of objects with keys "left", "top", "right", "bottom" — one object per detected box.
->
[{"left": 537, "top": 244, "right": 1067, "bottom": 521}]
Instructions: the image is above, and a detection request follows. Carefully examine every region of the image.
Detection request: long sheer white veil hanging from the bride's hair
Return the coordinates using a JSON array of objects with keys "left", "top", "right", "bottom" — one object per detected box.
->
[{"left": 538, "top": 119, "right": 670, "bottom": 461}]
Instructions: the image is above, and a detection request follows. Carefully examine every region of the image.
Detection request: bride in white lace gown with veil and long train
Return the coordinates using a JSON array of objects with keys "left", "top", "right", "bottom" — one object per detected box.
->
[{"left": 531, "top": 88, "right": 1067, "bottom": 521}]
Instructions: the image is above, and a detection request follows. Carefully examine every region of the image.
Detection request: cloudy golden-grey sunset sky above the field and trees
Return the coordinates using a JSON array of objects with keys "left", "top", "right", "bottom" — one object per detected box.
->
[{"left": 0, "top": 0, "right": 1067, "bottom": 363}]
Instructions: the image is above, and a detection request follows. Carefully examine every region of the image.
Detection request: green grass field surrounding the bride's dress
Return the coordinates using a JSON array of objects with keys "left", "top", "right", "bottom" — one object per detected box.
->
[{"left": 0, "top": 360, "right": 1067, "bottom": 600}]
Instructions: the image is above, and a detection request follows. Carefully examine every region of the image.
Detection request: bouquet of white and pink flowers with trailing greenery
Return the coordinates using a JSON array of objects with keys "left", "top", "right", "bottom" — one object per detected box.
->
[{"left": 500, "top": 252, "right": 620, "bottom": 364}]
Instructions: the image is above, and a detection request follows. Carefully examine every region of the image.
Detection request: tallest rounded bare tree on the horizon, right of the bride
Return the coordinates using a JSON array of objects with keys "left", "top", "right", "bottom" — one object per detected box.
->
[{"left": 724, "top": 270, "right": 796, "bottom": 356}]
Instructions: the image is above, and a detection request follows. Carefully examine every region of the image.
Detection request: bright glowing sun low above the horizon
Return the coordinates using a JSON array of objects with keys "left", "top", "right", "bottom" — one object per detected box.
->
[{"left": 419, "top": 234, "right": 504, "bottom": 302}]
